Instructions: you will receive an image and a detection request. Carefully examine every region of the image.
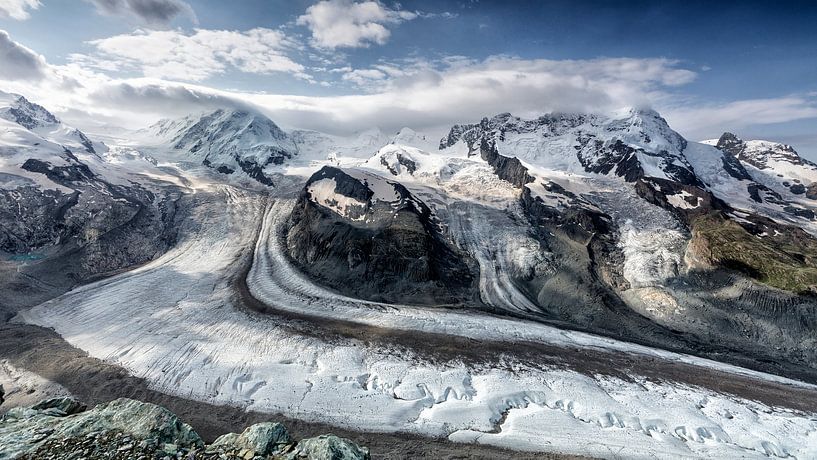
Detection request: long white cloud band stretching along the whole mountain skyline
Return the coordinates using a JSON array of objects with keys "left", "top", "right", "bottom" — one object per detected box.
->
[{"left": 0, "top": 31, "right": 817, "bottom": 158}]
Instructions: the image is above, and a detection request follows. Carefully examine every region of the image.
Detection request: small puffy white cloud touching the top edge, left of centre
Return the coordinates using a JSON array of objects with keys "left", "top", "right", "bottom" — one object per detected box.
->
[{"left": 297, "top": 0, "right": 418, "bottom": 49}]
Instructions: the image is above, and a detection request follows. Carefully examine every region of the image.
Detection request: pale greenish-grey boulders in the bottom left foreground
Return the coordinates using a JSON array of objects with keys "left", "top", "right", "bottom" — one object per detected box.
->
[{"left": 0, "top": 386, "right": 370, "bottom": 460}]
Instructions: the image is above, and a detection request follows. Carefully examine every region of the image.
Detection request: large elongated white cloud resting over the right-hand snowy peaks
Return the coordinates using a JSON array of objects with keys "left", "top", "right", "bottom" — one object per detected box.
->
[{"left": 306, "top": 56, "right": 696, "bottom": 131}]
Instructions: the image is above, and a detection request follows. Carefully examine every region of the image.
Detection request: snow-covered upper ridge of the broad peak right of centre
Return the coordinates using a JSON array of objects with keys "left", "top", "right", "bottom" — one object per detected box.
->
[{"left": 440, "top": 109, "right": 696, "bottom": 184}]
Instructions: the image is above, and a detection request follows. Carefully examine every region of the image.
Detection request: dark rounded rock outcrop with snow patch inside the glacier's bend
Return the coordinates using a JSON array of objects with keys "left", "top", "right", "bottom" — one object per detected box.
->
[{"left": 287, "top": 167, "right": 474, "bottom": 305}]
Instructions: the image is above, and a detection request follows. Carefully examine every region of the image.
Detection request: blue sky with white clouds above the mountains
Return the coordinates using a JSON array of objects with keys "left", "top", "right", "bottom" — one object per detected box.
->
[{"left": 0, "top": 0, "right": 817, "bottom": 160}]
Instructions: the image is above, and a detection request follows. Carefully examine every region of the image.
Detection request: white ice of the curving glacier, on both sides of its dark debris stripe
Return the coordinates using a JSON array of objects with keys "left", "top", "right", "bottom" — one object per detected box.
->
[{"left": 17, "top": 182, "right": 817, "bottom": 458}]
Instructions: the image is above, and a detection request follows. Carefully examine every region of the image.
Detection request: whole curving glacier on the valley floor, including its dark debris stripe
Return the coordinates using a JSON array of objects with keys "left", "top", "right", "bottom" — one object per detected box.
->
[{"left": 6, "top": 185, "right": 817, "bottom": 458}]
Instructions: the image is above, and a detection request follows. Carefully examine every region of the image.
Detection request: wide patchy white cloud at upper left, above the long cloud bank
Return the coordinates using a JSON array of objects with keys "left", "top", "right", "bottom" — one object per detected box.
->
[{"left": 71, "top": 28, "right": 308, "bottom": 81}]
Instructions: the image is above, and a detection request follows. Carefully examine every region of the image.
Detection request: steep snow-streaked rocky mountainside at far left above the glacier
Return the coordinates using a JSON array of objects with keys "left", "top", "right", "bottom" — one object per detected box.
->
[{"left": 0, "top": 93, "right": 180, "bottom": 312}]
